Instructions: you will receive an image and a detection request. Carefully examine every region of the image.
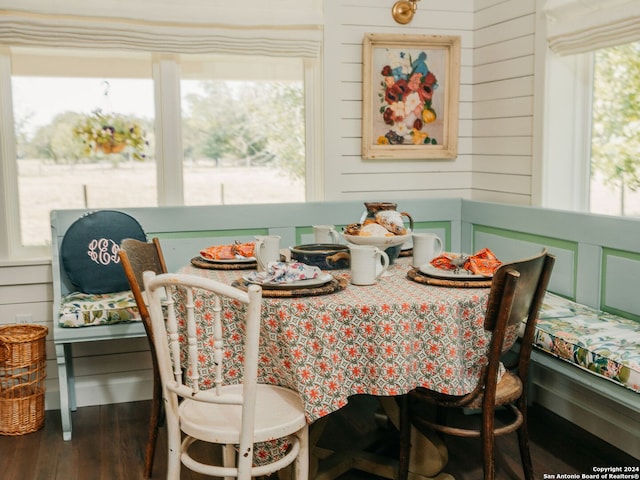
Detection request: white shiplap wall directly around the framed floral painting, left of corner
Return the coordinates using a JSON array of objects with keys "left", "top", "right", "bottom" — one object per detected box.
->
[{"left": 324, "top": 0, "right": 474, "bottom": 200}]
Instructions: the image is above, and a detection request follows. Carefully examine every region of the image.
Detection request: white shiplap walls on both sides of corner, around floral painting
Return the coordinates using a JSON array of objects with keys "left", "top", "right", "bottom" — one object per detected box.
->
[{"left": 324, "top": 0, "right": 536, "bottom": 205}]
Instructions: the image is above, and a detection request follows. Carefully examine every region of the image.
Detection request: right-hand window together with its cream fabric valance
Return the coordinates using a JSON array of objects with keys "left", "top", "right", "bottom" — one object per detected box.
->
[{"left": 536, "top": 0, "right": 640, "bottom": 216}]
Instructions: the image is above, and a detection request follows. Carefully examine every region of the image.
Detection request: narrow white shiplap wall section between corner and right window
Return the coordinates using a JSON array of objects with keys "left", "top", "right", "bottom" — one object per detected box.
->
[{"left": 471, "top": 0, "right": 541, "bottom": 205}]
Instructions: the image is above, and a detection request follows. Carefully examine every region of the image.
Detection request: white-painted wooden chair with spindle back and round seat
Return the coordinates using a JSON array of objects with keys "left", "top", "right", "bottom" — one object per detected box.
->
[{"left": 144, "top": 272, "right": 309, "bottom": 480}]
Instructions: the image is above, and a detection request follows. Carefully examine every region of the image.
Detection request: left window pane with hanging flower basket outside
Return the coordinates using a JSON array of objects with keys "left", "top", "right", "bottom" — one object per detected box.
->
[{"left": 11, "top": 49, "right": 157, "bottom": 251}]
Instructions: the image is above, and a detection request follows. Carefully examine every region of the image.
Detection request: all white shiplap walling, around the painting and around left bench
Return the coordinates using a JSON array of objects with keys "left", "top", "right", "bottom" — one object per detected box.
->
[{"left": 0, "top": 0, "right": 535, "bottom": 408}]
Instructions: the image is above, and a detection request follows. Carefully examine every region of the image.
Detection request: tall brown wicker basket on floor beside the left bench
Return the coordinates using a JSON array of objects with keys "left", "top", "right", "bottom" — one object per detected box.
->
[{"left": 0, "top": 325, "right": 47, "bottom": 435}]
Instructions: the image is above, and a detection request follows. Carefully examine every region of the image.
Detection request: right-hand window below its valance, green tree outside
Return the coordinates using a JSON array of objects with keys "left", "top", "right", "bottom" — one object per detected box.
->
[{"left": 542, "top": 42, "right": 640, "bottom": 216}]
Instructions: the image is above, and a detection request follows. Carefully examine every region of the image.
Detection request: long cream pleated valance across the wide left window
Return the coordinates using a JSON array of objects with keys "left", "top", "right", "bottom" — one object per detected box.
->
[{"left": 0, "top": 10, "right": 322, "bottom": 58}]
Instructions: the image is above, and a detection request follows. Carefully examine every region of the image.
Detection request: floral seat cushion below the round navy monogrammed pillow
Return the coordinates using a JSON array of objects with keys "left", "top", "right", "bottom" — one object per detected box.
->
[{"left": 58, "top": 290, "right": 140, "bottom": 327}]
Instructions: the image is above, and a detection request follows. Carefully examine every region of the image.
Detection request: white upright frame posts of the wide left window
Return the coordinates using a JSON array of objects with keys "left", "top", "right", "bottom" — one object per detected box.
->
[{"left": 0, "top": 47, "right": 324, "bottom": 261}]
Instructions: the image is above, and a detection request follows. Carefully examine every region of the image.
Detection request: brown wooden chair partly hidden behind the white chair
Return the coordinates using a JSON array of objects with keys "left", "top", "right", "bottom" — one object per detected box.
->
[{"left": 118, "top": 238, "right": 167, "bottom": 478}]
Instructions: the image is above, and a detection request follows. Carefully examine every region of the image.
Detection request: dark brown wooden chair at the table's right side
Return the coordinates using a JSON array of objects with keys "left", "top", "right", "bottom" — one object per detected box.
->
[{"left": 398, "top": 249, "right": 555, "bottom": 480}]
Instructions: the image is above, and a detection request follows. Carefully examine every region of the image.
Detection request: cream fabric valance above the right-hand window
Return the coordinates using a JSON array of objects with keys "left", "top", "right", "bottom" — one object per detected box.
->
[{"left": 544, "top": 0, "right": 640, "bottom": 55}]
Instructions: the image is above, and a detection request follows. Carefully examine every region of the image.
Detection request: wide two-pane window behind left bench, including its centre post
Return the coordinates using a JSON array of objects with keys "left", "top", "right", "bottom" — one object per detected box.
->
[{"left": 0, "top": 47, "right": 317, "bottom": 256}]
